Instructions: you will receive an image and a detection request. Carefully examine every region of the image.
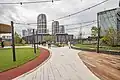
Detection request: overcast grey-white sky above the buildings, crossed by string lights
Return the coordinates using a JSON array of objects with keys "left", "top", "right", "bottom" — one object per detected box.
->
[{"left": 0, "top": 0, "right": 119, "bottom": 36}]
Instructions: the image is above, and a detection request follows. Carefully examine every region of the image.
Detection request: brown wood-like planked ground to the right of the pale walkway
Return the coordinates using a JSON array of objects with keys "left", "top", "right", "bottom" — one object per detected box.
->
[{"left": 79, "top": 51, "right": 120, "bottom": 80}]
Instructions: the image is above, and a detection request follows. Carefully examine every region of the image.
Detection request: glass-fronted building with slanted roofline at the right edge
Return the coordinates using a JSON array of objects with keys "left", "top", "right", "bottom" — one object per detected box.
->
[{"left": 97, "top": 8, "right": 120, "bottom": 45}]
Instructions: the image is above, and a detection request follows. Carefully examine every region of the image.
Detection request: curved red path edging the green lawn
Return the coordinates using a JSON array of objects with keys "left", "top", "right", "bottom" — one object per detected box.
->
[{"left": 0, "top": 48, "right": 50, "bottom": 80}]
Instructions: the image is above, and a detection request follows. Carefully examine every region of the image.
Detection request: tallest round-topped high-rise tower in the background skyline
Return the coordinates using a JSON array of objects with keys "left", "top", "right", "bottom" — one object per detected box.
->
[{"left": 37, "top": 14, "right": 47, "bottom": 33}]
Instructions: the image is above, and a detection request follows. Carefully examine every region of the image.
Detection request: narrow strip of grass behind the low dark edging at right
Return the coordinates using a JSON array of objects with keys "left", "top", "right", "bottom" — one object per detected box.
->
[{"left": 75, "top": 44, "right": 120, "bottom": 51}]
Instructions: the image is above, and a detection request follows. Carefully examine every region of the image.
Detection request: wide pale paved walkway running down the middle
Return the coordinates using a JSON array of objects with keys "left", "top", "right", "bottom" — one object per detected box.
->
[{"left": 16, "top": 47, "right": 99, "bottom": 80}]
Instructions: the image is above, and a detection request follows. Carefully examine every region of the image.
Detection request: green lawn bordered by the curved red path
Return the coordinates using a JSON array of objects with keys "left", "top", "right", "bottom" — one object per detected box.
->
[{"left": 0, "top": 48, "right": 40, "bottom": 72}]
